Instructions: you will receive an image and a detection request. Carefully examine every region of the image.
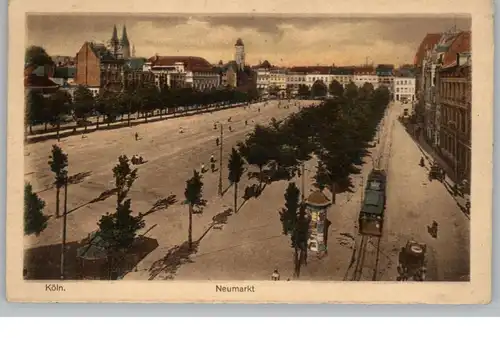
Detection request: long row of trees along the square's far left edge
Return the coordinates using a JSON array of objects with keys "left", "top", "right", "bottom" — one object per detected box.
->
[{"left": 26, "top": 85, "right": 257, "bottom": 137}]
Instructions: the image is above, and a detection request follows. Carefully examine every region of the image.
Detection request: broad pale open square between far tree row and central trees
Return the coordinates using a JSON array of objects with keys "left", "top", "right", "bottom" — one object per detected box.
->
[{"left": 25, "top": 101, "right": 314, "bottom": 274}]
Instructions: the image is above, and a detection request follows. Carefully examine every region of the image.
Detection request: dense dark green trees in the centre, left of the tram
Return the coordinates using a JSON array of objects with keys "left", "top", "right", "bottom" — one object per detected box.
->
[{"left": 233, "top": 82, "right": 390, "bottom": 274}]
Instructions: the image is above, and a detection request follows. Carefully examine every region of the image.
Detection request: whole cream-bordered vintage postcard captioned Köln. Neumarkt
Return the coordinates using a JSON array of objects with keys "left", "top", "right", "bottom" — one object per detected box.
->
[{"left": 7, "top": 0, "right": 493, "bottom": 304}]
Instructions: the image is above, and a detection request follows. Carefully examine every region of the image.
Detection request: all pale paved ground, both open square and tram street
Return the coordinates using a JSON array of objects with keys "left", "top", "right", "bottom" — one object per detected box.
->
[{"left": 25, "top": 101, "right": 469, "bottom": 280}]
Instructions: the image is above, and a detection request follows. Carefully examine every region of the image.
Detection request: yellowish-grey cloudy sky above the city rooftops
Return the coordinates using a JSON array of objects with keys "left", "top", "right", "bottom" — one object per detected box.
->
[{"left": 27, "top": 15, "right": 470, "bottom": 66}]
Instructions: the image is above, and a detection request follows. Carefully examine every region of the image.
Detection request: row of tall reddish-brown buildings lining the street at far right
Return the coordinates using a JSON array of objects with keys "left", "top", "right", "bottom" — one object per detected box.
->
[{"left": 415, "top": 29, "right": 472, "bottom": 180}]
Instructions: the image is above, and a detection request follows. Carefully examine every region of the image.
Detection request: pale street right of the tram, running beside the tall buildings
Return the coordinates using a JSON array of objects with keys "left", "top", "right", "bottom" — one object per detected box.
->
[{"left": 344, "top": 104, "right": 470, "bottom": 281}]
